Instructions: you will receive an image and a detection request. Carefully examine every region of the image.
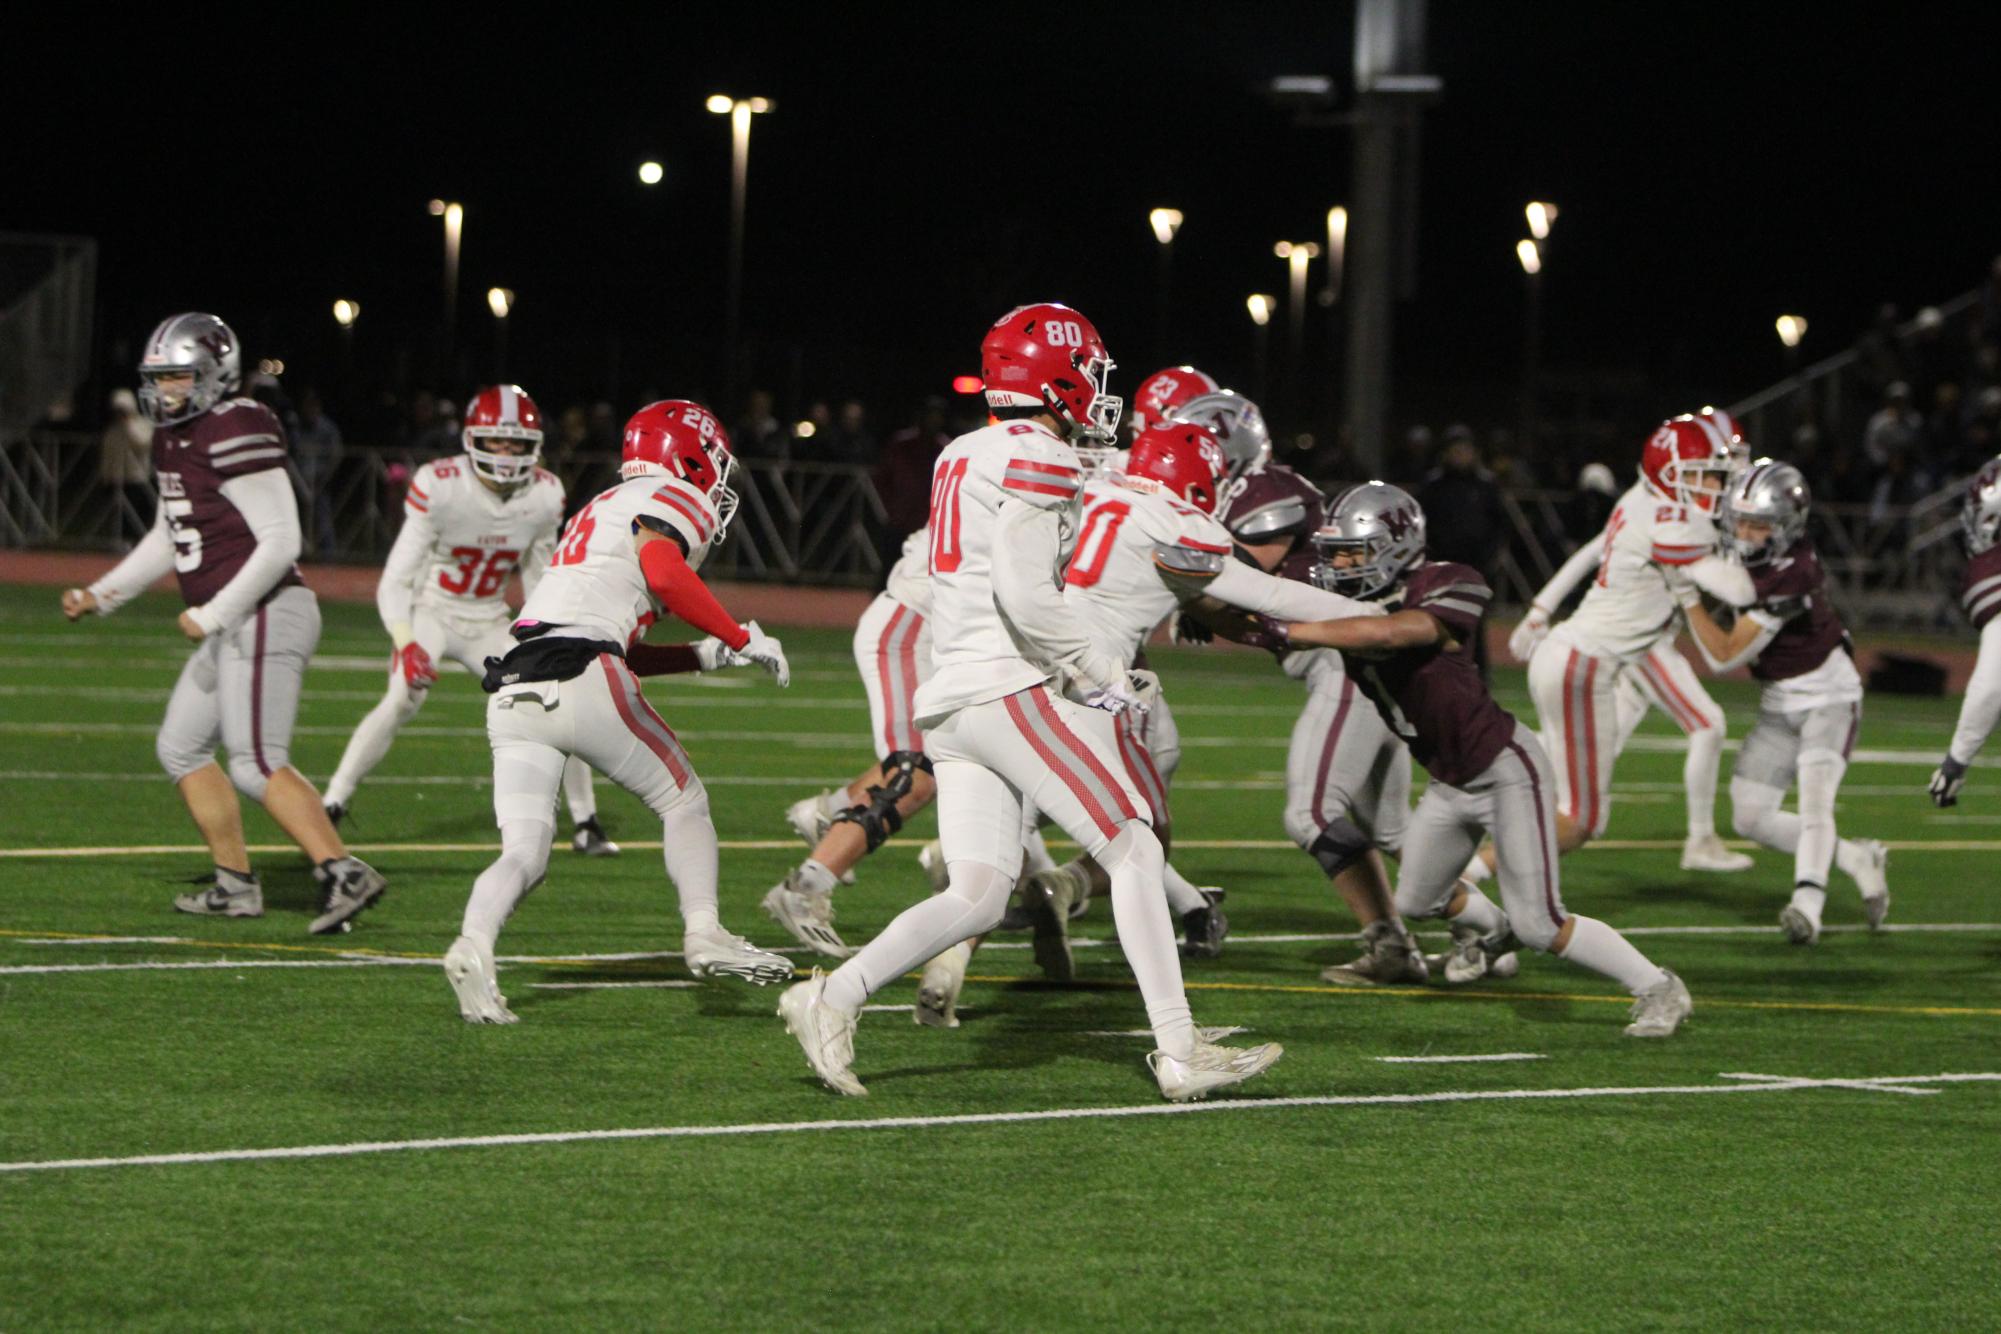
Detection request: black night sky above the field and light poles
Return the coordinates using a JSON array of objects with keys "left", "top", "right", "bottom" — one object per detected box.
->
[{"left": 0, "top": 0, "right": 2001, "bottom": 438}]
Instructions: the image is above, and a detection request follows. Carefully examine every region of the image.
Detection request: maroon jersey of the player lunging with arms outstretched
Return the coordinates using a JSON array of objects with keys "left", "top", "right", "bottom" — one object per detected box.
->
[{"left": 1343, "top": 560, "right": 1515, "bottom": 786}]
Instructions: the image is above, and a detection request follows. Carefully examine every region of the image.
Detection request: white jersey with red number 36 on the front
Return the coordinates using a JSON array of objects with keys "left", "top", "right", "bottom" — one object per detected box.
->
[{"left": 376, "top": 458, "right": 562, "bottom": 628}]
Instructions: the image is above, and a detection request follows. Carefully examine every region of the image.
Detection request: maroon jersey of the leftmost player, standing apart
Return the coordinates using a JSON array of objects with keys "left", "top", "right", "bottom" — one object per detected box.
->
[{"left": 152, "top": 398, "right": 302, "bottom": 606}]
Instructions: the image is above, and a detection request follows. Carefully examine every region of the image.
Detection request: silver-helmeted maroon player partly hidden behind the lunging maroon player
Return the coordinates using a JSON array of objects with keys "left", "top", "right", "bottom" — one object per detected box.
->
[{"left": 1175, "top": 390, "right": 1429, "bottom": 986}]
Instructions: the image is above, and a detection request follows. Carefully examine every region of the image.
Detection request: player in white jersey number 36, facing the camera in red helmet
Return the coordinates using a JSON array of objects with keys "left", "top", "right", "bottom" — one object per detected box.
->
[{"left": 326, "top": 384, "right": 616, "bottom": 856}]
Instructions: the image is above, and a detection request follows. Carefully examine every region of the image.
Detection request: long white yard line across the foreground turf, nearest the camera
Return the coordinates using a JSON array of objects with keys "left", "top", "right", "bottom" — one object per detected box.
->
[{"left": 0, "top": 1074, "right": 2001, "bottom": 1172}]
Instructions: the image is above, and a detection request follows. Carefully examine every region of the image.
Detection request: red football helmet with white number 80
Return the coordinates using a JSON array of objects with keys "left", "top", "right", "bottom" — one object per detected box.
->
[{"left": 980, "top": 302, "right": 1125, "bottom": 448}]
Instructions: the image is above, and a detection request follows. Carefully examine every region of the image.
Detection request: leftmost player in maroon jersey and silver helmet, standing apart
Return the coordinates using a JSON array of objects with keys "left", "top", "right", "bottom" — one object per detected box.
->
[{"left": 62, "top": 312, "right": 386, "bottom": 934}]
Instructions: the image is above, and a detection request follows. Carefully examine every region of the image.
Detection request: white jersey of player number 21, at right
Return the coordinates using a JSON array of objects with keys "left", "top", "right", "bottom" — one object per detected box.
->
[{"left": 1563, "top": 482, "right": 1717, "bottom": 664}]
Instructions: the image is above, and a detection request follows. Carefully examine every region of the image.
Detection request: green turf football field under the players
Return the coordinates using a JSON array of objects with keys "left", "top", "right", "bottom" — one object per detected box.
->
[{"left": 0, "top": 590, "right": 2001, "bottom": 1330}]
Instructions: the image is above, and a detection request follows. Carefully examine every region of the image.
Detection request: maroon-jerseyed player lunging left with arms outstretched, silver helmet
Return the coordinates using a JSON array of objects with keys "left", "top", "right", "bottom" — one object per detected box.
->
[{"left": 1277, "top": 482, "right": 1693, "bottom": 1038}]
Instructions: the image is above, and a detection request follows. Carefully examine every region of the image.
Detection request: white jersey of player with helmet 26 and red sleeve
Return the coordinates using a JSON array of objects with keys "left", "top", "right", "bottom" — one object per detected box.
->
[{"left": 514, "top": 476, "right": 716, "bottom": 646}]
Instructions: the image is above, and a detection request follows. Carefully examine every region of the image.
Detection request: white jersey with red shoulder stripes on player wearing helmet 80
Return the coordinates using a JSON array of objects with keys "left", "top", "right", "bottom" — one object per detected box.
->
[{"left": 916, "top": 422, "right": 1083, "bottom": 726}]
